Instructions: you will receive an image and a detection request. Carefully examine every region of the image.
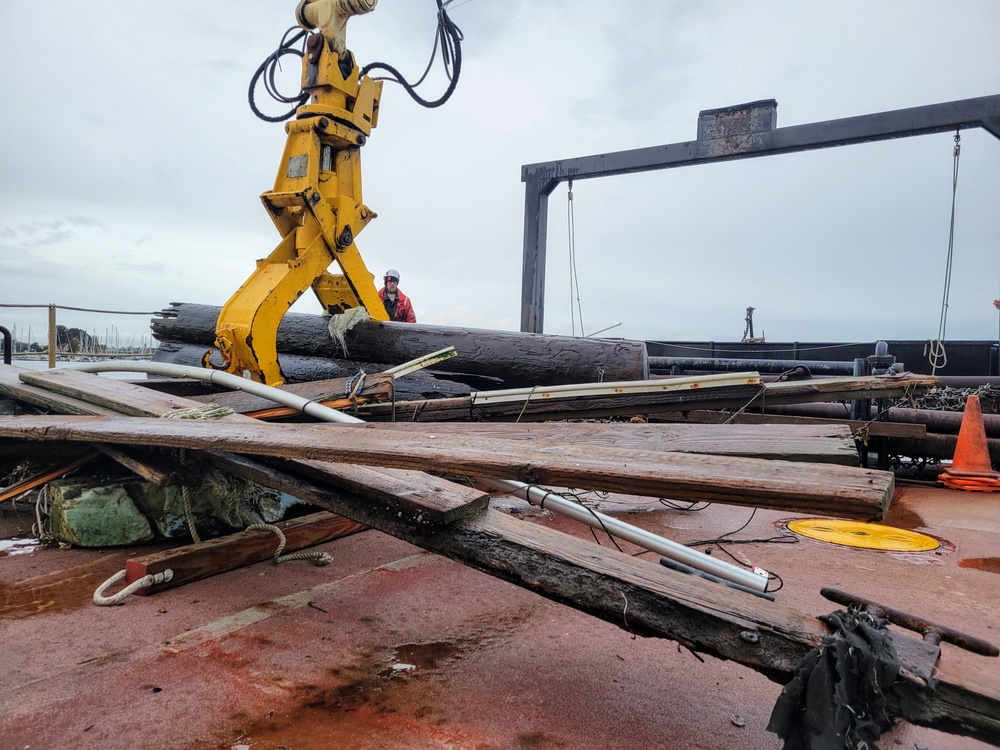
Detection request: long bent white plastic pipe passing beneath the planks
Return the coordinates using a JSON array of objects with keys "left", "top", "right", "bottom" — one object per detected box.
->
[{"left": 67, "top": 360, "right": 767, "bottom": 591}]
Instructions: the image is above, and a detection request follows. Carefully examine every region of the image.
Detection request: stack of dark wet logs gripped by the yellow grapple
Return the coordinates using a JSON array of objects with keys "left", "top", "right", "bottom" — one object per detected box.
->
[{"left": 151, "top": 302, "right": 649, "bottom": 400}]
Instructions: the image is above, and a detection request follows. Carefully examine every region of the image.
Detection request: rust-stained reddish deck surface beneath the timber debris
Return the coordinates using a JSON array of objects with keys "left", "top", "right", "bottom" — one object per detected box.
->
[{"left": 0, "top": 485, "right": 1000, "bottom": 750}]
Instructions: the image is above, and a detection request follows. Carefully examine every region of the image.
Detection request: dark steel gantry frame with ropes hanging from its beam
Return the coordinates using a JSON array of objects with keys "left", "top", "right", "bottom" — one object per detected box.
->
[{"left": 521, "top": 94, "right": 1000, "bottom": 333}]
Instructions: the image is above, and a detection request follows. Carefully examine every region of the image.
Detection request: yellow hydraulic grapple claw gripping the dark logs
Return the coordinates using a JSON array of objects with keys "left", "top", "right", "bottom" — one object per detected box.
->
[{"left": 204, "top": 20, "right": 388, "bottom": 385}]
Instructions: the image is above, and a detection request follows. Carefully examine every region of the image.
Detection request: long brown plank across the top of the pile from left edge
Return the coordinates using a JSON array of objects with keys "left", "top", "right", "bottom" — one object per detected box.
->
[{"left": 0, "top": 417, "right": 893, "bottom": 520}]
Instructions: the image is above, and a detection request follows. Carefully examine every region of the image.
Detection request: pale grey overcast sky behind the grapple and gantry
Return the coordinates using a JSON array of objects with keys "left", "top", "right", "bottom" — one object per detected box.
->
[{"left": 0, "top": 0, "right": 1000, "bottom": 352}]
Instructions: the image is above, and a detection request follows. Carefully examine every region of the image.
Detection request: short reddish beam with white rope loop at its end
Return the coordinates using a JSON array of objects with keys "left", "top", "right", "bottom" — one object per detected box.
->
[{"left": 125, "top": 511, "right": 367, "bottom": 596}]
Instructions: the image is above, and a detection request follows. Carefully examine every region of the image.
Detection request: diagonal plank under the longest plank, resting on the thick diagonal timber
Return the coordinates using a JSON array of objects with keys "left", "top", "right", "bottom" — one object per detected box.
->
[{"left": 11, "top": 370, "right": 489, "bottom": 524}]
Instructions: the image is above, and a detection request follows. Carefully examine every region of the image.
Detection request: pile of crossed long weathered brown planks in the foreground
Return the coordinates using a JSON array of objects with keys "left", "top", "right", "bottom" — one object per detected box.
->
[{"left": 0, "top": 366, "right": 1000, "bottom": 741}]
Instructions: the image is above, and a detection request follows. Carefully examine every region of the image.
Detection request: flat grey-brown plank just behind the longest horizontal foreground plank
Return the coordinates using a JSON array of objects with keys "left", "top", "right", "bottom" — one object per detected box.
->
[{"left": 365, "top": 424, "right": 858, "bottom": 466}]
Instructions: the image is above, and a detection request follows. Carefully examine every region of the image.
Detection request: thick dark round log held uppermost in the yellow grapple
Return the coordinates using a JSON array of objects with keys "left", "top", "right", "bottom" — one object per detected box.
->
[{"left": 151, "top": 302, "right": 649, "bottom": 388}]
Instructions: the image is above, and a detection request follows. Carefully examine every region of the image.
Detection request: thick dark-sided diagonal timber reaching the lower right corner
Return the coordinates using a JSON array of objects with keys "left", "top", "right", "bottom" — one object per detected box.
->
[{"left": 217, "top": 452, "right": 1000, "bottom": 744}]
